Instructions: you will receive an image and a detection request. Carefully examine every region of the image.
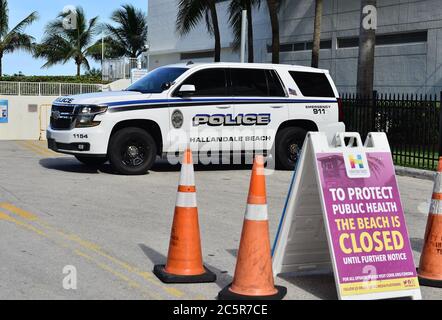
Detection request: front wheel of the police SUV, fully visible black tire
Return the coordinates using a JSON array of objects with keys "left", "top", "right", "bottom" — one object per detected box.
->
[{"left": 108, "top": 127, "right": 157, "bottom": 175}]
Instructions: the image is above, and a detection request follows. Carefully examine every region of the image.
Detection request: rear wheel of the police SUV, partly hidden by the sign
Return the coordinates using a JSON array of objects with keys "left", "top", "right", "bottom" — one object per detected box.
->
[{"left": 275, "top": 127, "right": 307, "bottom": 170}]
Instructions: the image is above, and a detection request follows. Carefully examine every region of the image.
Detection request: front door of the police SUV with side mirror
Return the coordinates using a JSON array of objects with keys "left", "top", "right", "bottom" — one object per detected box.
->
[{"left": 170, "top": 67, "right": 233, "bottom": 158}]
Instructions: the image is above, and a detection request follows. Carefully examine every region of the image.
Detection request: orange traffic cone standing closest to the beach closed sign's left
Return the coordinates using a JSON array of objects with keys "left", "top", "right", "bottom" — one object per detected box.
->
[{"left": 218, "top": 156, "right": 287, "bottom": 300}]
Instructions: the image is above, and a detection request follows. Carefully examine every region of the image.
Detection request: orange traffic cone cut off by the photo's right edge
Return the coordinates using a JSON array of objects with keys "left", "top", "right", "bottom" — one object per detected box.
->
[{"left": 418, "top": 157, "right": 442, "bottom": 288}]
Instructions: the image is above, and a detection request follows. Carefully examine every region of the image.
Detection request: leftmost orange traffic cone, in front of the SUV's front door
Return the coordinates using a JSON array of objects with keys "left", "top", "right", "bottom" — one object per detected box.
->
[{"left": 153, "top": 149, "right": 216, "bottom": 283}]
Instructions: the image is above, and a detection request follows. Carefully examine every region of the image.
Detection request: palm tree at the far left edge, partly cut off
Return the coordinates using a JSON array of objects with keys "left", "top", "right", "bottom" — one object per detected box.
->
[{"left": 0, "top": 0, "right": 38, "bottom": 77}]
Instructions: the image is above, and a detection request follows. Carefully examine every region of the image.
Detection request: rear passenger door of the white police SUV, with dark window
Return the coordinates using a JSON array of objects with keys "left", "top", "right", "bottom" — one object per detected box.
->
[{"left": 230, "top": 68, "right": 288, "bottom": 155}]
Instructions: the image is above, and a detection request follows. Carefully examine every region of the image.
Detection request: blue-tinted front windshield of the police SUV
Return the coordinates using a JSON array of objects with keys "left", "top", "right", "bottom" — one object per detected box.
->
[{"left": 126, "top": 67, "right": 189, "bottom": 93}]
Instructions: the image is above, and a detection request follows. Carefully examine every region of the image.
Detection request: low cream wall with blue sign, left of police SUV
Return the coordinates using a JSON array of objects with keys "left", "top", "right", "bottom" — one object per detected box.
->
[{"left": 0, "top": 96, "right": 56, "bottom": 140}]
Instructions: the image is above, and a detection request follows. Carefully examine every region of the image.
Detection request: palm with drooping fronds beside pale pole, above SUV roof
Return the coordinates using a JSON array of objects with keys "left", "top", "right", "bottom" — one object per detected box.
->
[{"left": 229, "top": 0, "right": 261, "bottom": 63}]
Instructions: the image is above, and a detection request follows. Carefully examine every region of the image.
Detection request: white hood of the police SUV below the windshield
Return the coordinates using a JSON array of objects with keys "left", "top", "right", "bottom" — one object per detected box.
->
[{"left": 54, "top": 91, "right": 152, "bottom": 105}]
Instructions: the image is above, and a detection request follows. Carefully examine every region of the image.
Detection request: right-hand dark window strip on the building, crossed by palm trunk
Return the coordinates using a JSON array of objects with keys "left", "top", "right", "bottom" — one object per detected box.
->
[{"left": 338, "top": 31, "right": 428, "bottom": 49}]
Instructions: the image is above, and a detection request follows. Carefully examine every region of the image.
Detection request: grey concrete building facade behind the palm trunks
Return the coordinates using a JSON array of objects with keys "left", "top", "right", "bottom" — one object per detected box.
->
[{"left": 149, "top": 0, "right": 442, "bottom": 93}]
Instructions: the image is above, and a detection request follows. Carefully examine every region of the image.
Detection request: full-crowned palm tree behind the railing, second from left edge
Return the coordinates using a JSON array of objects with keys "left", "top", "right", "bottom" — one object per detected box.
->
[{"left": 35, "top": 7, "right": 100, "bottom": 76}]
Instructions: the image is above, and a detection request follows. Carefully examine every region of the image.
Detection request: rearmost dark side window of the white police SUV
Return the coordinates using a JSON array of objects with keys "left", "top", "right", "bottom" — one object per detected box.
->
[{"left": 289, "top": 71, "right": 335, "bottom": 98}]
